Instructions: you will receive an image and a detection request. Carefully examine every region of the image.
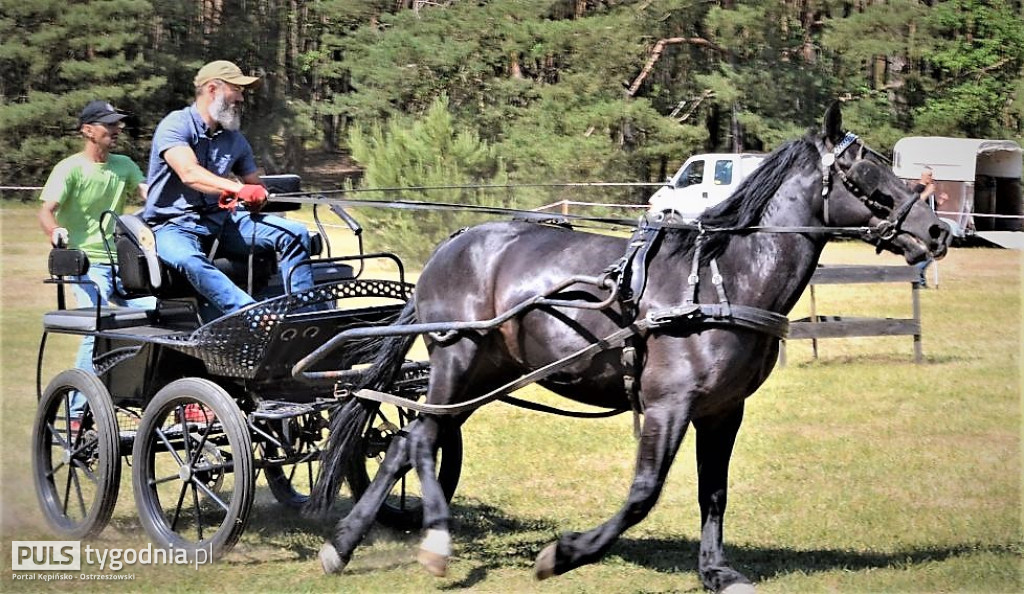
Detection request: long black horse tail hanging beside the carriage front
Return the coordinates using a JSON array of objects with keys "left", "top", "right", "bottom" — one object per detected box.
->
[{"left": 303, "top": 299, "right": 416, "bottom": 516}]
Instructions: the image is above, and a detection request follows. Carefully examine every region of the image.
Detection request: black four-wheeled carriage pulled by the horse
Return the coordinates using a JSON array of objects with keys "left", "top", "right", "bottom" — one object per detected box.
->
[{"left": 33, "top": 176, "right": 462, "bottom": 558}]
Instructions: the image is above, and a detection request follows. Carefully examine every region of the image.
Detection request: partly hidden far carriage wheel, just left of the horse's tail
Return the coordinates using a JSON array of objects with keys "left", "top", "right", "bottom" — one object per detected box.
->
[{"left": 262, "top": 413, "right": 324, "bottom": 509}]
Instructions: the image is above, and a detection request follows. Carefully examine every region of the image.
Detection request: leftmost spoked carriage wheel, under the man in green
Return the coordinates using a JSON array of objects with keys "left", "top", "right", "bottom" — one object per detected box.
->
[{"left": 32, "top": 369, "right": 121, "bottom": 540}]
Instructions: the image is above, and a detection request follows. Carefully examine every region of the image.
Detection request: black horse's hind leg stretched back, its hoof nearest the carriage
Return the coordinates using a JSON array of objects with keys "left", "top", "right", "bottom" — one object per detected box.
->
[{"left": 319, "top": 430, "right": 415, "bottom": 574}]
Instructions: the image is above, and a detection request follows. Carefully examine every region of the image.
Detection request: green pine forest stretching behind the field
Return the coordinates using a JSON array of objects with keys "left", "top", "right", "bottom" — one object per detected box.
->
[{"left": 0, "top": 0, "right": 1024, "bottom": 257}]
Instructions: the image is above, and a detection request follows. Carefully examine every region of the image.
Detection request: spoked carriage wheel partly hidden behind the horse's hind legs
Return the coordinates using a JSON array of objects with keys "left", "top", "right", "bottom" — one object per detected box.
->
[{"left": 348, "top": 405, "right": 462, "bottom": 529}]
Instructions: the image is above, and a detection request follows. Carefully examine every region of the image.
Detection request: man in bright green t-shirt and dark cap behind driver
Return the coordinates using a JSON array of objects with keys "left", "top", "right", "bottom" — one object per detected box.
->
[{"left": 39, "top": 101, "right": 156, "bottom": 414}]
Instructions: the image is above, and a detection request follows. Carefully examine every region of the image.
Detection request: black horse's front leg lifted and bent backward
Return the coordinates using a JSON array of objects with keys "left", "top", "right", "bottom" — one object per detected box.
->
[{"left": 534, "top": 397, "right": 689, "bottom": 580}]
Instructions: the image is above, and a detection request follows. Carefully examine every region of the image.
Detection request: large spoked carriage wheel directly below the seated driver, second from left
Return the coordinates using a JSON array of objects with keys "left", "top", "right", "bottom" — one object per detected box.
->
[{"left": 132, "top": 378, "right": 255, "bottom": 558}]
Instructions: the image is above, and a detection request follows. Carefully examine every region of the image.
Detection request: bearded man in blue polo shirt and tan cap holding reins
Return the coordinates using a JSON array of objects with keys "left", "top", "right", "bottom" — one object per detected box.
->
[{"left": 142, "top": 60, "right": 312, "bottom": 317}]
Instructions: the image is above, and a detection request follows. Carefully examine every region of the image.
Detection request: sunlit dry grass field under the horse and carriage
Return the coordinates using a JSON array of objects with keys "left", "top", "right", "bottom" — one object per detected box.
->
[{"left": 0, "top": 204, "right": 1024, "bottom": 593}]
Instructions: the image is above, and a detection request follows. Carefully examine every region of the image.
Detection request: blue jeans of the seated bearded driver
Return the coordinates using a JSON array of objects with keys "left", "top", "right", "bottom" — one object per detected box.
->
[{"left": 156, "top": 212, "right": 313, "bottom": 319}]
